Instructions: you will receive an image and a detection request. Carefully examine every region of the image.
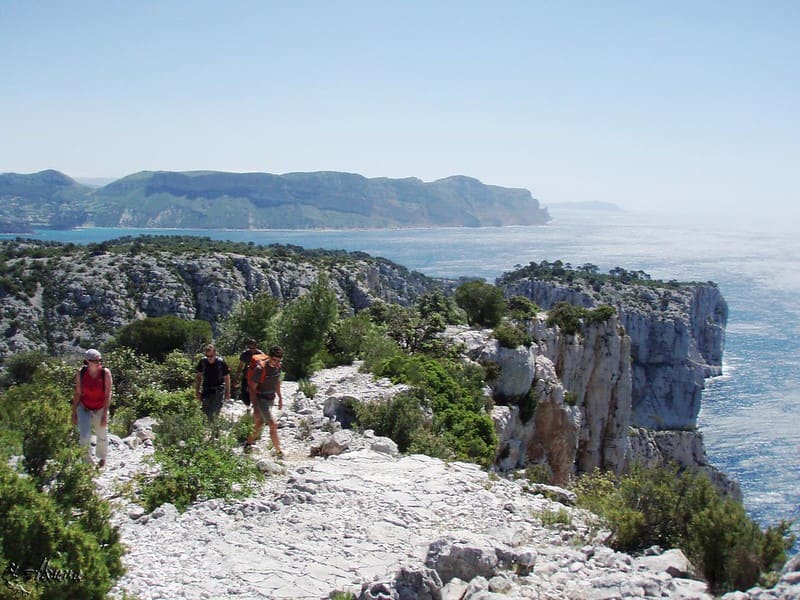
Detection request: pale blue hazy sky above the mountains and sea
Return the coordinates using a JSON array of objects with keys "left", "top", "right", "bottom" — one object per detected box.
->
[{"left": 0, "top": 0, "right": 800, "bottom": 215}]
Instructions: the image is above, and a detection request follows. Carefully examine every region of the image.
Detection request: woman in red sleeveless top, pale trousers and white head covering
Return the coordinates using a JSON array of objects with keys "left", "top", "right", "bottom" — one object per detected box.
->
[{"left": 72, "top": 348, "right": 114, "bottom": 468}]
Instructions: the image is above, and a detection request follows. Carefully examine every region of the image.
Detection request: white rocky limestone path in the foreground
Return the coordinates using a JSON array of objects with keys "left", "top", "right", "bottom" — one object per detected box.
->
[{"left": 98, "top": 367, "right": 796, "bottom": 600}]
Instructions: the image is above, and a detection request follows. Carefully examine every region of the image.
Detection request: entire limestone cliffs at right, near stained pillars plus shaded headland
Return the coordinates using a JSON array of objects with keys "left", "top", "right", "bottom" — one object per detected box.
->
[{"left": 449, "top": 279, "right": 741, "bottom": 498}]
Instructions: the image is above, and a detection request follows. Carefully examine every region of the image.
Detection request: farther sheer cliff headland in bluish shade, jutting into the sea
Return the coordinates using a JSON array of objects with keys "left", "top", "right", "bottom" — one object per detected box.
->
[{"left": 504, "top": 278, "right": 728, "bottom": 429}]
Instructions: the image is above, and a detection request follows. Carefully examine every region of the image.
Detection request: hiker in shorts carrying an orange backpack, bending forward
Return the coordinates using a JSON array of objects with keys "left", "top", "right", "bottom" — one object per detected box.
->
[{"left": 244, "top": 346, "right": 283, "bottom": 458}]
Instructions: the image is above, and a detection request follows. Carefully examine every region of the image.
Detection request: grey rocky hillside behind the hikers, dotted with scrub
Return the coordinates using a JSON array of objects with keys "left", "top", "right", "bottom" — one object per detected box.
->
[{"left": 0, "top": 240, "right": 436, "bottom": 360}]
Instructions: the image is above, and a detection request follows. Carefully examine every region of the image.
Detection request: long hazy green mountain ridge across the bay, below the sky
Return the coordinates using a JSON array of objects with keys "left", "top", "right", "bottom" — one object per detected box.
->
[{"left": 0, "top": 170, "right": 550, "bottom": 231}]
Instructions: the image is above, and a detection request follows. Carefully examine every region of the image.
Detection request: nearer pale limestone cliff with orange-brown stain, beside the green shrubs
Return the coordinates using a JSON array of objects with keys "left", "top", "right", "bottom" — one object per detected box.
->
[{"left": 446, "top": 317, "right": 631, "bottom": 483}]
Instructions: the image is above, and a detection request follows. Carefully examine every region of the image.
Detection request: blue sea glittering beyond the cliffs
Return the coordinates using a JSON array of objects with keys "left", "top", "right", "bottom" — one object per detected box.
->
[{"left": 0, "top": 206, "right": 800, "bottom": 551}]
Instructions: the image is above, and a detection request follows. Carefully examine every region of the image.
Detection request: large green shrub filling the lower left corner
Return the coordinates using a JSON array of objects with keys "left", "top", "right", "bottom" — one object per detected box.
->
[{"left": 0, "top": 378, "right": 123, "bottom": 599}]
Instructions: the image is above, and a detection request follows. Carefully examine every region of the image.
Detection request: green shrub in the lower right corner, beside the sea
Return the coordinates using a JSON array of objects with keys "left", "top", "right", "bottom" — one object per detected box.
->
[{"left": 575, "top": 466, "right": 794, "bottom": 594}]
